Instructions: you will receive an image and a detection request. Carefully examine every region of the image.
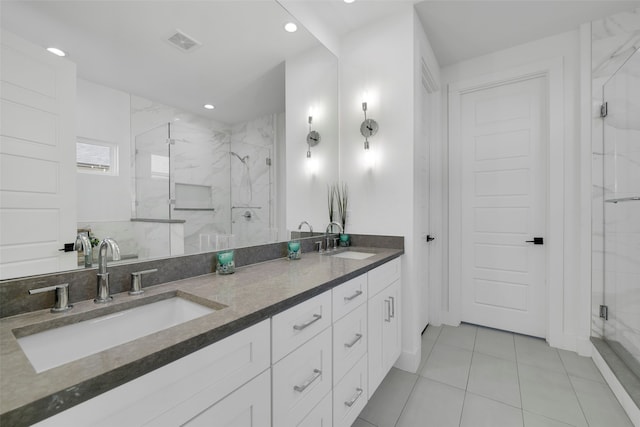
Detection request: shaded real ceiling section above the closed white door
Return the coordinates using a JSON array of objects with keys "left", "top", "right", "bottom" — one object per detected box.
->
[{"left": 415, "top": 0, "right": 640, "bottom": 67}]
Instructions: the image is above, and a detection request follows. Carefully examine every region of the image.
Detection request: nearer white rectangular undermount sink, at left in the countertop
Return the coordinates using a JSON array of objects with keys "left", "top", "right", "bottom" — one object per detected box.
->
[{"left": 18, "top": 295, "right": 216, "bottom": 372}]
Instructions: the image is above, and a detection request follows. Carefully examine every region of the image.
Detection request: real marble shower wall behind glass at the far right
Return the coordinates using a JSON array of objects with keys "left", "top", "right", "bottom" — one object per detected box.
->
[{"left": 592, "top": 9, "right": 640, "bottom": 359}]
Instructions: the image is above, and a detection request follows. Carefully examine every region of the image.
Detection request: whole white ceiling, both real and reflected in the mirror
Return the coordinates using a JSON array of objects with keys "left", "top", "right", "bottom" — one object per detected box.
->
[{"left": 0, "top": 0, "right": 640, "bottom": 124}]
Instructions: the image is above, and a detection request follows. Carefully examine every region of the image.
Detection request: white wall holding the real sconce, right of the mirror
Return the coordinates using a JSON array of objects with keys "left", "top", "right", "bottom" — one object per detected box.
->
[{"left": 339, "top": 4, "right": 421, "bottom": 371}]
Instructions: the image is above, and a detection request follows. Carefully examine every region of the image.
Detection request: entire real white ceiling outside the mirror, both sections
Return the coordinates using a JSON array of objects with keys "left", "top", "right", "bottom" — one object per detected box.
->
[{"left": 302, "top": 0, "right": 640, "bottom": 67}]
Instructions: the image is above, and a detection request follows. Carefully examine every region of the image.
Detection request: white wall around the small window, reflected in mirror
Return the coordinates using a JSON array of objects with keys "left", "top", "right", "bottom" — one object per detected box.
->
[{"left": 76, "top": 79, "right": 131, "bottom": 222}]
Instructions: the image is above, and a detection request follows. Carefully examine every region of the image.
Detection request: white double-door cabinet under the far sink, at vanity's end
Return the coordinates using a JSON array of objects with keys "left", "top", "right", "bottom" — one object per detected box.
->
[{"left": 368, "top": 258, "right": 402, "bottom": 398}]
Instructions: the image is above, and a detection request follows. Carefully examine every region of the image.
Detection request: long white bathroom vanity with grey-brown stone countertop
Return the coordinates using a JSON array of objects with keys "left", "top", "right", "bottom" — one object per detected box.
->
[{"left": 0, "top": 247, "right": 403, "bottom": 427}]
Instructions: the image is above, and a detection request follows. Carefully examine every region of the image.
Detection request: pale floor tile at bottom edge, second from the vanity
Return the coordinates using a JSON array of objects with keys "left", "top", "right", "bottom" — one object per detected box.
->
[{"left": 396, "top": 378, "right": 464, "bottom": 427}]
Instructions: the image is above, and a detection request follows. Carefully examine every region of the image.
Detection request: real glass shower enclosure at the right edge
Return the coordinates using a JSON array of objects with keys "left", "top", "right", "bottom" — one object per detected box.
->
[{"left": 592, "top": 47, "right": 640, "bottom": 384}]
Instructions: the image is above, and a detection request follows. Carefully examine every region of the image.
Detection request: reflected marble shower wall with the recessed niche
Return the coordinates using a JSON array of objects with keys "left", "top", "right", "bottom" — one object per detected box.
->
[{"left": 131, "top": 96, "right": 231, "bottom": 255}]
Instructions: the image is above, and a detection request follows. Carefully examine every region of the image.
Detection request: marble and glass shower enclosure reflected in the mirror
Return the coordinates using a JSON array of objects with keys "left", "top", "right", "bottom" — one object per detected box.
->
[{"left": 133, "top": 118, "right": 272, "bottom": 256}]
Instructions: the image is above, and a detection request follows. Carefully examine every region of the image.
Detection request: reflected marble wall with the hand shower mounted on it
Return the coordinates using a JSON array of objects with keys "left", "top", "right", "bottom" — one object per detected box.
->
[{"left": 230, "top": 114, "right": 278, "bottom": 246}]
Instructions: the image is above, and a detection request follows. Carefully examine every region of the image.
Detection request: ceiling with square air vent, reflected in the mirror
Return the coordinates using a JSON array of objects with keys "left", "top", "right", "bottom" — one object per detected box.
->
[{"left": 0, "top": 0, "right": 320, "bottom": 124}]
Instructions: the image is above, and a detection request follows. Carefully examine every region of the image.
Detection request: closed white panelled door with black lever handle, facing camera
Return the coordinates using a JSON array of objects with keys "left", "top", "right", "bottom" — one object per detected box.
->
[{"left": 460, "top": 77, "right": 548, "bottom": 337}]
